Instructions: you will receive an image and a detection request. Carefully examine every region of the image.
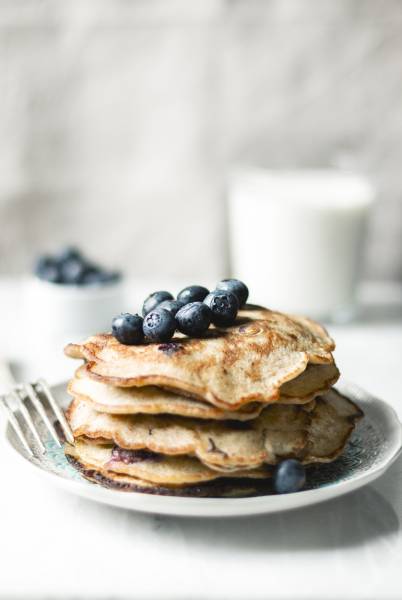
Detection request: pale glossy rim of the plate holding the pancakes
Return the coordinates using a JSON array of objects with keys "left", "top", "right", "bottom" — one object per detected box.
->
[{"left": 2, "top": 381, "right": 402, "bottom": 518}]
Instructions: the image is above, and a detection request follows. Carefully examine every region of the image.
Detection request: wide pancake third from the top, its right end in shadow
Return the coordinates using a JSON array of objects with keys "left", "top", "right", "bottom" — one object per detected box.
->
[{"left": 67, "top": 390, "right": 362, "bottom": 476}]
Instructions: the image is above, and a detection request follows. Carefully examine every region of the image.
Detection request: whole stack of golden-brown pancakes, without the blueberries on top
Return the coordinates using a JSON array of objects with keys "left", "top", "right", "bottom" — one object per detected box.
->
[{"left": 65, "top": 305, "right": 362, "bottom": 497}]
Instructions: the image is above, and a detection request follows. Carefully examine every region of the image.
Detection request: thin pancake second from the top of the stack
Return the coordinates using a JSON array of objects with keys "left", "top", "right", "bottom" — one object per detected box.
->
[{"left": 68, "top": 365, "right": 263, "bottom": 421}]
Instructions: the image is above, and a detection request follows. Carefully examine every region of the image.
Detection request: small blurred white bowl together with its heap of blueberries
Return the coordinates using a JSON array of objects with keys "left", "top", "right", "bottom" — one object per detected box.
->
[{"left": 28, "top": 247, "right": 124, "bottom": 344}]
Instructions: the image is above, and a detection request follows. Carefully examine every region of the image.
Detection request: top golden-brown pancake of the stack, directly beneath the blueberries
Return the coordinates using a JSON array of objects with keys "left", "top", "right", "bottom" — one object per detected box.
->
[{"left": 65, "top": 306, "right": 335, "bottom": 411}]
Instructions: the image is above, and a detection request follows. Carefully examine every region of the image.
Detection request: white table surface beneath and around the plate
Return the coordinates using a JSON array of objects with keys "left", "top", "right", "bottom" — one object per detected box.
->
[{"left": 0, "top": 283, "right": 402, "bottom": 600}]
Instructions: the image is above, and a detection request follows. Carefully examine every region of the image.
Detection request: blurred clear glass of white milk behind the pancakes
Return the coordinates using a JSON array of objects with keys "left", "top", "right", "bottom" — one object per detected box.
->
[{"left": 228, "top": 168, "right": 374, "bottom": 321}]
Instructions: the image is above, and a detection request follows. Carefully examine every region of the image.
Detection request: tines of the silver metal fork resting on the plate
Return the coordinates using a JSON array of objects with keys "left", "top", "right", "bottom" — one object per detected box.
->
[{"left": 0, "top": 379, "right": 74, "bottom": 457}]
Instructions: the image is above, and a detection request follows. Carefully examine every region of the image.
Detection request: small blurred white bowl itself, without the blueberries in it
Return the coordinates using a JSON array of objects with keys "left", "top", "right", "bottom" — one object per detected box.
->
[{"left": 23, "top": 277, "right": 125, "bottom": 344}]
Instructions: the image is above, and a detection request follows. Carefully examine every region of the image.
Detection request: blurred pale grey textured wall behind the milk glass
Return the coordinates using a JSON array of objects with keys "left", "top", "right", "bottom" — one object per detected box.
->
[{"left": 0, "top": 0, "right": 402, "bottom": 281}]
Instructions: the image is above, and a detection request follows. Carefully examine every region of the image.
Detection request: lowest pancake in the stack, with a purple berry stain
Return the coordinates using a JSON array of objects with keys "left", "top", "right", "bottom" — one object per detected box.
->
[{"left": 65, "top": 439, "right": 271, "bottom": 486}]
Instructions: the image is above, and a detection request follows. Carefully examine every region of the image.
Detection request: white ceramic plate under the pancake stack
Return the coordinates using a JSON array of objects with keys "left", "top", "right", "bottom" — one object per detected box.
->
[{"left": 5, "top": 383, "right": 402, "bottom": 517}]
